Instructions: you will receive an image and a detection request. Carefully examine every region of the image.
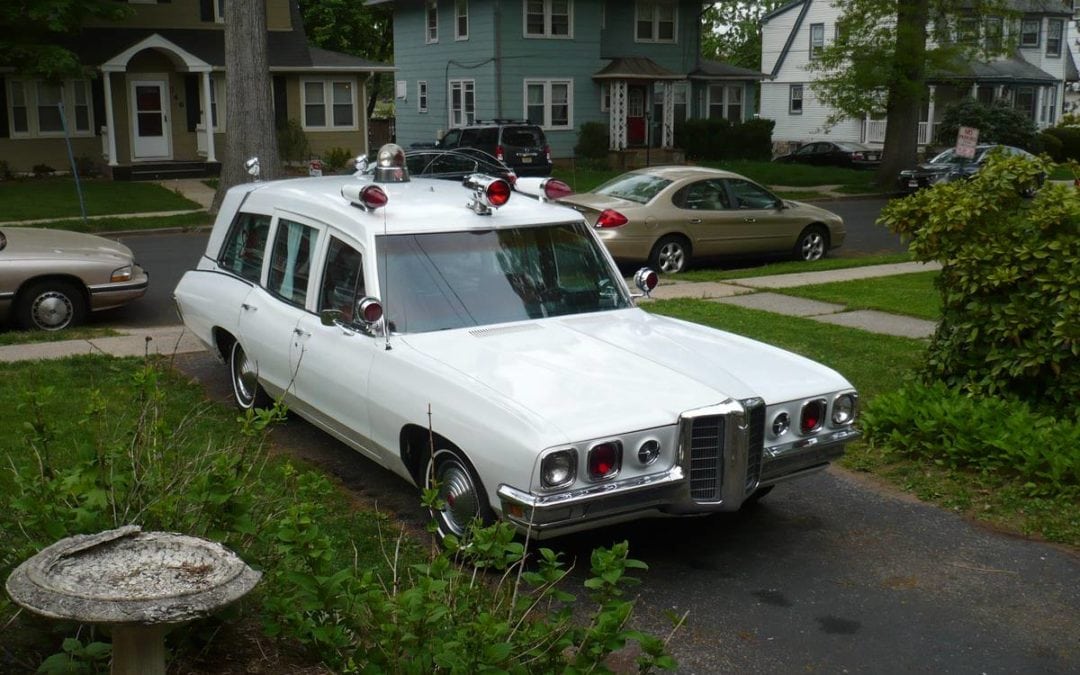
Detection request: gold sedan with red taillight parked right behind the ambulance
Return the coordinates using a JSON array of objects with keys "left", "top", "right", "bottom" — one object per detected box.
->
[{"left": 559, "top": 166, "right": 846, "bottom": 274}]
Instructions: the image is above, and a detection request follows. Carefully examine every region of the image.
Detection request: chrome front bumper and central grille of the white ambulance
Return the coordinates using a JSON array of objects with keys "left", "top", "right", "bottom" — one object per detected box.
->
[{"left": 498, "top": 403, "right": 861, "bottom": 538}]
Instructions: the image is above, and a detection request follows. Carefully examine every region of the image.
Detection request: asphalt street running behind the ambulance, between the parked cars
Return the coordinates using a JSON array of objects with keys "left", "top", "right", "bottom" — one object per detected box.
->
[{"left": 92, "top": 199, "right": 907, "bottom": 327}]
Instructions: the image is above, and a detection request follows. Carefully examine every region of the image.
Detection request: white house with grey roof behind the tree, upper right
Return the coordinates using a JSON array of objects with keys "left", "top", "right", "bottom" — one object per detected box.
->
[{"left": 760, "top": 0, "right": 1076, "bottom": 149}]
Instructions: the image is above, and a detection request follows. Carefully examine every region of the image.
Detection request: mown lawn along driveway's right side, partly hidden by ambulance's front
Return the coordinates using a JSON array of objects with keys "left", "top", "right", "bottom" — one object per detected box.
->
[{"left": 646, "top": 300, "right": 1080, "bottom": 546}]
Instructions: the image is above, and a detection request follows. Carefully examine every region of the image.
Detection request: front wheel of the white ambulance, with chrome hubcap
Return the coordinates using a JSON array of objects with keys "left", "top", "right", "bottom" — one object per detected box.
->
[{"left": 427, "top": 448, "right": 495, "bottom": 541}]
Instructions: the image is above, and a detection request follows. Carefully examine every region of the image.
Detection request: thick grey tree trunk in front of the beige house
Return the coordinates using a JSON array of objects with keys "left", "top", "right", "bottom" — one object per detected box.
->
[{"left": 211, "top": 0, "right": 281, "bottom": 213}]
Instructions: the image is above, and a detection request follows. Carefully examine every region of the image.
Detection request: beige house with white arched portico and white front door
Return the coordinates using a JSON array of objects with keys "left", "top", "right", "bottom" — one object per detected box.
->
[{"left": 0, "top": 0, "right": 393, "bottom": 179}]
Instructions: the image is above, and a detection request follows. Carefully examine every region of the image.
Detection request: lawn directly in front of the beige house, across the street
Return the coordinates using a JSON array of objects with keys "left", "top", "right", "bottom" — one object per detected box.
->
[{"left": 0, "top": 178, "right": 201, "bottom": 220}]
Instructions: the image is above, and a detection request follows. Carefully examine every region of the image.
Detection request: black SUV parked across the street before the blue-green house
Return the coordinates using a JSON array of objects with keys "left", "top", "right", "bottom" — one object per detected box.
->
[{"left": 435, "top": 120, "right": 551, "bottom": 176}]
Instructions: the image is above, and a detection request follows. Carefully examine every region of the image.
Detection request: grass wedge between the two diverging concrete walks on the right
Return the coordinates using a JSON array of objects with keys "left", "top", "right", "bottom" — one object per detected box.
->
[{"left": 774, "top": 271, "right": 942, "bottom": 321}]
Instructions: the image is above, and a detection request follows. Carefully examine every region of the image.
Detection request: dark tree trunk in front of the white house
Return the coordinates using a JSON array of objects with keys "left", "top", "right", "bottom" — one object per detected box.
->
[{"left": 876, "top": 0, "right": 930, "bottom": 188}]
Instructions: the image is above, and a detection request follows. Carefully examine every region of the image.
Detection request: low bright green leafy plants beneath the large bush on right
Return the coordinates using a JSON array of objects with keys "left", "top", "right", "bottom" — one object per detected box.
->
[{"left": 860, "top": 382, "right": 1080, "bottom": 496}]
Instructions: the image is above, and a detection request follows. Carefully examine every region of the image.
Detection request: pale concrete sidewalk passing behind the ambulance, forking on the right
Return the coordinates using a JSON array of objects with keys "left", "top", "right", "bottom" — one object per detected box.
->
[{"left": 0, "top": 262, "right": 937, "bottom": 362}]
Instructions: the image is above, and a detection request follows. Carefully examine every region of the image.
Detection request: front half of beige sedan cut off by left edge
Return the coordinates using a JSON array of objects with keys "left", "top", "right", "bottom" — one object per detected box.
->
[{"left": 0, "top": 227, "right": 149, "bottom": 330}]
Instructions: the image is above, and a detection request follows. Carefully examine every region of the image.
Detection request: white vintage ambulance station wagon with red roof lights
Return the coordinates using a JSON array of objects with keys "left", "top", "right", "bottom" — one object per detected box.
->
[{"left": 175, "top": 146, "right": 859, "bottom": 538}]
